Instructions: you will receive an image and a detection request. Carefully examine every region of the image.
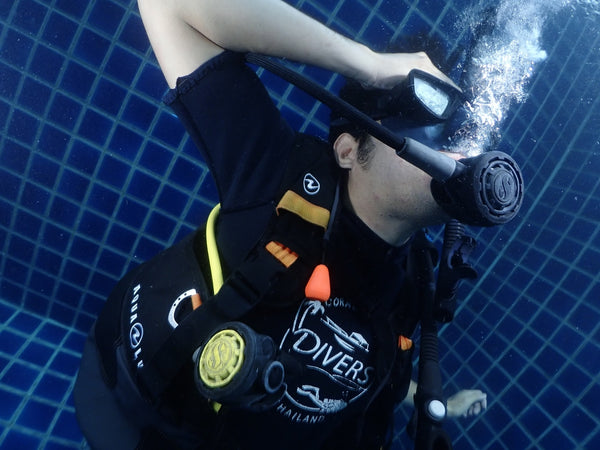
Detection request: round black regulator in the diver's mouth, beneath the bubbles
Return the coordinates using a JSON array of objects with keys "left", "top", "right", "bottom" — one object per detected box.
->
[{"left": 431, "top": 151, "right": 524, "bottom": 227}]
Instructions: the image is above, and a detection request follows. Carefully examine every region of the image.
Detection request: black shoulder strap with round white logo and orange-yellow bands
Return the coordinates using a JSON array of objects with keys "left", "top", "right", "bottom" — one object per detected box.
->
[{"left": 139, "top": 135, "right": 338, "bottom": 402}]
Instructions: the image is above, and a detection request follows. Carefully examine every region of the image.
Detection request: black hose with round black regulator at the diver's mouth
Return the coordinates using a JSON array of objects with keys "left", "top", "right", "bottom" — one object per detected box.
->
[{"left": 246, "top": 53, "right": 523, "bottom": 226}]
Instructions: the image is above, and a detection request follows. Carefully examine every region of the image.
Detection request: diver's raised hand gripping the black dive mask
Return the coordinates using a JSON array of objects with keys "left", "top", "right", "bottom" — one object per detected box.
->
[{"left": 363, "top": 52, "right": 458, "bottom": 89}]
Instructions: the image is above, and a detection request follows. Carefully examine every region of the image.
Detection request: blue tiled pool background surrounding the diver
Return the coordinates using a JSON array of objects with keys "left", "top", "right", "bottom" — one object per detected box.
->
[{"left": 0, "top": 0, "right": 600, "bottom": 449}]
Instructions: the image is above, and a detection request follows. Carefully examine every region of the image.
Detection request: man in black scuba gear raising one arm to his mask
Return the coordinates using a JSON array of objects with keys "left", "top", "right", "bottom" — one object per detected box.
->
[{"left": 74, "top": 0, "right": 516, "bottom": 449}]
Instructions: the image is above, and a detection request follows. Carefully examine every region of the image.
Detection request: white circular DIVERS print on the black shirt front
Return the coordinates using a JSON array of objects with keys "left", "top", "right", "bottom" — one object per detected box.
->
[{"left": 276, "top": 301, "right": 375, "bottom": 423}]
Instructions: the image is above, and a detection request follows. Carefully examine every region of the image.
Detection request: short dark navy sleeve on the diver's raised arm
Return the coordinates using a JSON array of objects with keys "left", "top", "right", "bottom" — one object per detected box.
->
[{"left": 165, "top": 52, "right": 295, "bottom": 212}]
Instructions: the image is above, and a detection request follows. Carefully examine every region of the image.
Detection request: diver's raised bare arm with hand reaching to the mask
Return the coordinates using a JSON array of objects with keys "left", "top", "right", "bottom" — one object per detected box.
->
[{"left": 138, "top": 0, "right": 450, "bottom": 87}]
